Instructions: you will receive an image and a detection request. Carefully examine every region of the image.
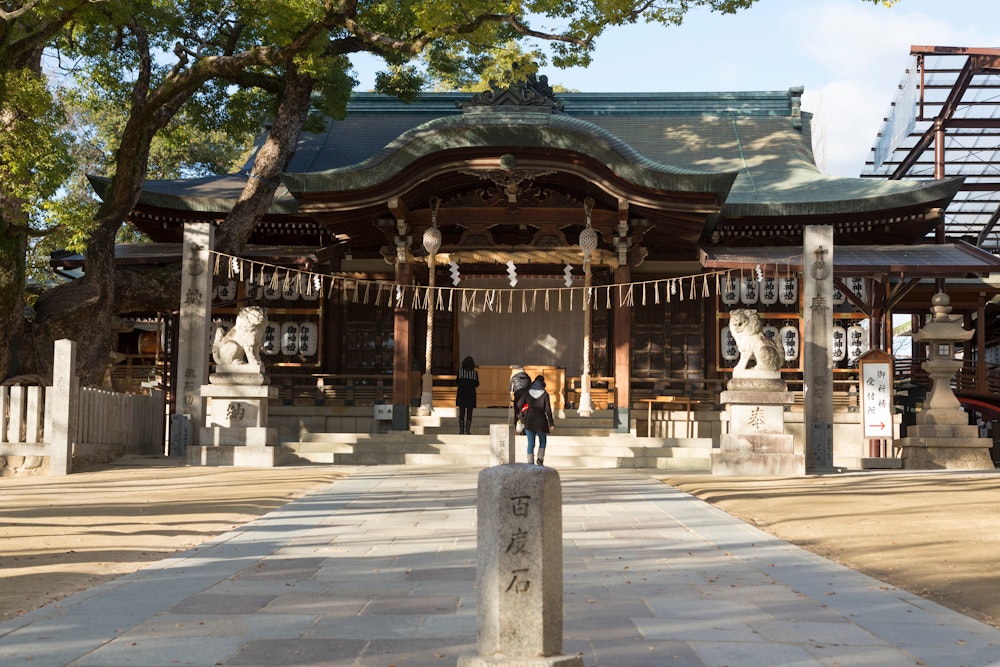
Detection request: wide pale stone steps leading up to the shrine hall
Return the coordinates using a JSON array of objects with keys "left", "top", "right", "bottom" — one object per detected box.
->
[{"left": 285, "top": 410, "right": 712, "bottom": 471}]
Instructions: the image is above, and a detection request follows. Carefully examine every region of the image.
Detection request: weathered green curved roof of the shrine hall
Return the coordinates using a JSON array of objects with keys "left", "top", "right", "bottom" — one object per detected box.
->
[{"left": 127, "top": 90, "right": 960, "bottom": 217}]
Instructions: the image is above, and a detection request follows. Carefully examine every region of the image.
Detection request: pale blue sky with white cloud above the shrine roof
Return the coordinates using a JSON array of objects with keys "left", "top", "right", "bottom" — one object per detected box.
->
[{"left": 356, "top": 0, "right": 1000, "bottom": 176}]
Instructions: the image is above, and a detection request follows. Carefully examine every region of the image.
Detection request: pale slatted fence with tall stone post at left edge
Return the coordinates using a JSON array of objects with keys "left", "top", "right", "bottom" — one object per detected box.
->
[{"left": 0, "top": 341, "right": 165, "bottom": 476}]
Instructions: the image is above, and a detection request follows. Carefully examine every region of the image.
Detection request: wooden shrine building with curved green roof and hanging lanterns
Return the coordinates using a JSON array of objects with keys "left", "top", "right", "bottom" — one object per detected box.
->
[{"left": 74, "top": 77, "right": 1000, "bottom": 466}]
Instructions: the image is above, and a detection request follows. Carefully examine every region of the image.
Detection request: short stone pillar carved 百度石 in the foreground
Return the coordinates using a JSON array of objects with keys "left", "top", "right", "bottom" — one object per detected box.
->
[{"left": 458, "top": 463, "right": 583, "bottom": 667}]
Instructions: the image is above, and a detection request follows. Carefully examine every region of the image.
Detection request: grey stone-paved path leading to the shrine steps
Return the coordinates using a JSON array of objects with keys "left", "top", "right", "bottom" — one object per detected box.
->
[{"left": 0, "top": 466, "right": 1000, "bottom": 667}]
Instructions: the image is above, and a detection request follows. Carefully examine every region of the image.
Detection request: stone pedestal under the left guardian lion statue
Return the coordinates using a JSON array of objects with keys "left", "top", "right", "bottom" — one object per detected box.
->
[{"left": 187, "top": 366, "right": 289, "bottom": 468}]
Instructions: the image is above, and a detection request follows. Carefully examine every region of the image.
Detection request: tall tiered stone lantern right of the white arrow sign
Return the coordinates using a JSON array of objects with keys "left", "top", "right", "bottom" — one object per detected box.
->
[{"left": 898, "top": 292, "right": 994, "bottom": 470}]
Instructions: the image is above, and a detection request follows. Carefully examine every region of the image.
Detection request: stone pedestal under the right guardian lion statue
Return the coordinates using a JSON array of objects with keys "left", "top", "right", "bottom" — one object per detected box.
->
[{"left": 712, "top": 370, "right": 806, "bottom": 475}]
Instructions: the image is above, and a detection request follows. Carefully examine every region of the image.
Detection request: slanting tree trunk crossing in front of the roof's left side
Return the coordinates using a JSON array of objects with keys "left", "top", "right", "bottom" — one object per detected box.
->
[{"left": 215, "top": 69, "right": 313, "bottom": 255}]
